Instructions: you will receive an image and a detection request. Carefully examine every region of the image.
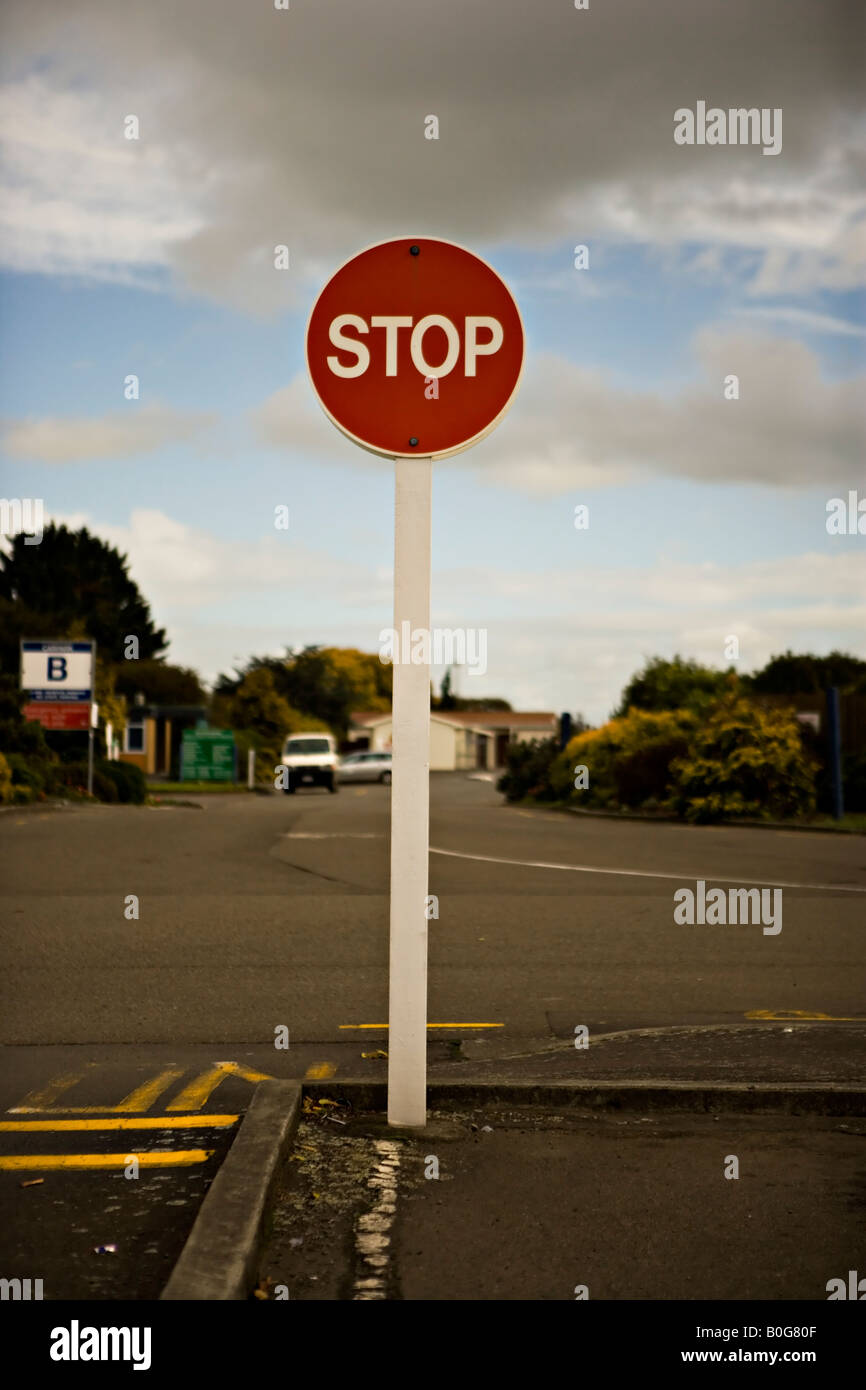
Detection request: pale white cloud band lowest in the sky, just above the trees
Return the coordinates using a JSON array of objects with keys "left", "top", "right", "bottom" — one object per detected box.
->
[{"left": 53, "top": 509, "right": 866, "bottom": 720}]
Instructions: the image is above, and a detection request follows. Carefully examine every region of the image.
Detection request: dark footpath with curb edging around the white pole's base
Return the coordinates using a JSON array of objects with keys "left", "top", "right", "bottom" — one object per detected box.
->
[{"left": 163, "top": 1020, "right": 866, "bottom": 1315}]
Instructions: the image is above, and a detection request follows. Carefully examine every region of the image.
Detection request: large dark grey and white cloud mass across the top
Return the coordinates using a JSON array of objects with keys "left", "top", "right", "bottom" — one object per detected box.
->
[{"left": 4, "top": 0, "right": 866, "bottom": 309}]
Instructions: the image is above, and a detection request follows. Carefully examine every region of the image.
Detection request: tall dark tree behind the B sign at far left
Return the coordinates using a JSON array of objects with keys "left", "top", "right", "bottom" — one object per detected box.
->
[{"left": 0, "top": 524, "right": 167, "bottom": 671}]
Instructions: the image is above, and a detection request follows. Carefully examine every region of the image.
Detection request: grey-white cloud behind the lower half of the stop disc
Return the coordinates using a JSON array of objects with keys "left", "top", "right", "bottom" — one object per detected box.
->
[{"left": 252, "top": 328, "right": 866, "bottom": 493}]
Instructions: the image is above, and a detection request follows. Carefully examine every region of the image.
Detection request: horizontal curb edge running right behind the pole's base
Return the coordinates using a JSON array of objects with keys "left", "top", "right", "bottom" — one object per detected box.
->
[{"left": 303, "top": 1080, "right": 866, "bottom": 1116}]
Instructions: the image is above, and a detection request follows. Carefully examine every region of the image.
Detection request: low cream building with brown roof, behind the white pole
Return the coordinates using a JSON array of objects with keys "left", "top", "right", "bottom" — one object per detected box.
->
[{"left": 349, "top": 709, "right": 559, "bottom": 771}]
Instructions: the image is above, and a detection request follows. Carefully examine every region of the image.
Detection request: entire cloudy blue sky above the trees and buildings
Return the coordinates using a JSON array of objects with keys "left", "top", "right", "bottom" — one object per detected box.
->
[{"left": 0, "top": 0, "right": 866, "bottom": 720}]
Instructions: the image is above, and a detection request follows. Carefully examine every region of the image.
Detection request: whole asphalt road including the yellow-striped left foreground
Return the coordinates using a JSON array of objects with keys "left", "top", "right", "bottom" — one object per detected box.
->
[{"left": 0, "top": 776, "right": 866, "bottom": 1298}]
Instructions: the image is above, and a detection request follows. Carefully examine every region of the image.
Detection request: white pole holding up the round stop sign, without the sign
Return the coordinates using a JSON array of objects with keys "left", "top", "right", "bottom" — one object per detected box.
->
[{"left": 388, "top": 459, "right": 432, "bottom": 1126}]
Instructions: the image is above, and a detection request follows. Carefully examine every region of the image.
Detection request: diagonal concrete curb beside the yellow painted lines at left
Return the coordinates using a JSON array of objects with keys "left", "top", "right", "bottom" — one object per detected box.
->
[{"left": 161, "top": 1080, "right": 300, "bottom": 1301}]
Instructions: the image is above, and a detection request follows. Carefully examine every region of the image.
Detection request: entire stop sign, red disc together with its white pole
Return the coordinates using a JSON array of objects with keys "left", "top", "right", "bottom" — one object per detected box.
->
[{"left": 306, "top": 236, "right": 524, "bottom": 1127}]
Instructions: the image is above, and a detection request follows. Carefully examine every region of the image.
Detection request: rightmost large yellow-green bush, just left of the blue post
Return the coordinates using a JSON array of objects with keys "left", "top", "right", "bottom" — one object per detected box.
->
[{"left": 671, "top": 695, "right": 816, "bottom": 823}]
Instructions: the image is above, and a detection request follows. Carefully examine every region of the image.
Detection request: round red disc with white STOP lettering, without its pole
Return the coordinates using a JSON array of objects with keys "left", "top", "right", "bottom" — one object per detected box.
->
[{"left": 307, "top": 236, "right": 524, "bottom": 459}]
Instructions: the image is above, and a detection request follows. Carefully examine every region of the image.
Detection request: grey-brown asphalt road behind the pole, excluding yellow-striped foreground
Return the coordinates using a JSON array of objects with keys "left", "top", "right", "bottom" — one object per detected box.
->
[{"left": 0, "top": 776, "right": 866, "bottom": 1045}]
